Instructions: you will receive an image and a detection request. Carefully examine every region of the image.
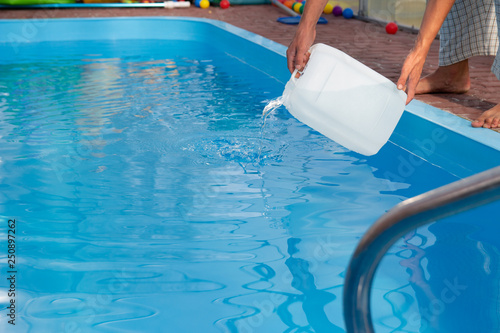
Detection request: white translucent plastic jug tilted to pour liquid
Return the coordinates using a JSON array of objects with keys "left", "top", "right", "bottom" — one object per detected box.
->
[{"left": 283, "top": 44, "right": 406, "bottom": 155}]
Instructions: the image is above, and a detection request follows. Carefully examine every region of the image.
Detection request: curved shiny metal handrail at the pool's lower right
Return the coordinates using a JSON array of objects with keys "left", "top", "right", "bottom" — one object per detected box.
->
[{"left": 344, "top": 167, "right": 500, "bottom": 333}]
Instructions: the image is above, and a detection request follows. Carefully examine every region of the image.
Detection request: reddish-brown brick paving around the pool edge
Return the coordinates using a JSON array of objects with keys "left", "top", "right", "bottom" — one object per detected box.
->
[{"left": 0, "top": 5, "right": 500, "bottom": 124}]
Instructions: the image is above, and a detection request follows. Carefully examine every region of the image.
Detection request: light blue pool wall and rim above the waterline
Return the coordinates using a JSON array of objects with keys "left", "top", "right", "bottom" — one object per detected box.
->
[{"left": 0, "top": 17, "right": 500, "bottom": 178}]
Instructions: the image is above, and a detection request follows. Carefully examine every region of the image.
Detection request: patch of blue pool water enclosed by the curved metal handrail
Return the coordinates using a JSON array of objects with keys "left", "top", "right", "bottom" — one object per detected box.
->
[{"left": 372, "top": 204, "right": 500, "bottom": 333}]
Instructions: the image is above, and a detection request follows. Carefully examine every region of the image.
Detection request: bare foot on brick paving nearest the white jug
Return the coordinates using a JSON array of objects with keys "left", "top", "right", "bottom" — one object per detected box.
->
[{"left": 415, "top": 59, "right": 470, "bottom": 94}]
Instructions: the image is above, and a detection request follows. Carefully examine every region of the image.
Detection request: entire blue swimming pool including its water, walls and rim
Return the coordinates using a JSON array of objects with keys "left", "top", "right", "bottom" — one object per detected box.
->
[{"left": 0, "top": 18, "right": 500, "bottom": 332}]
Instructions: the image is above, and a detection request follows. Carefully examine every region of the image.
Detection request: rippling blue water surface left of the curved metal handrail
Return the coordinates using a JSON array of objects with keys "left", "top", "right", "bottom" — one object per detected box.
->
[{"left": 0, "top": 41, "right": 494, "bottom": 333}]
